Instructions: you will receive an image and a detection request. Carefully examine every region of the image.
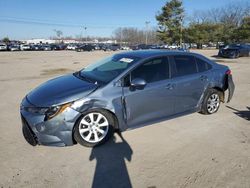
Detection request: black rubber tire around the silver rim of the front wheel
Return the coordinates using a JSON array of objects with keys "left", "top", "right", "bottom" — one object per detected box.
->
[{"left": 73, "top": 109, "right": 116, "bottom": 147}]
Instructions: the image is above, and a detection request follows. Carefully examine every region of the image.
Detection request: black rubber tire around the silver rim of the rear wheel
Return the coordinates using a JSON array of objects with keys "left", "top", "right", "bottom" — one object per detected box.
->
[{"left": 200, "top": 89, "right": 221, "bottom": 115}]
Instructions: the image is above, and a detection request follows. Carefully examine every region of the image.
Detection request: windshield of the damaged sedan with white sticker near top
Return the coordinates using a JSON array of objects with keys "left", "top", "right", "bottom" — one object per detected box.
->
[{"left": 79, "top": 54, "right": 139, "bottom": 83}]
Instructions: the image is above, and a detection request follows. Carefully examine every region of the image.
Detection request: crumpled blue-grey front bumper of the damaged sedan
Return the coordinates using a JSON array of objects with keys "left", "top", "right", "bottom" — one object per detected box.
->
[{"left": 20, "top": 98, "right": 81, "bottom": 146}]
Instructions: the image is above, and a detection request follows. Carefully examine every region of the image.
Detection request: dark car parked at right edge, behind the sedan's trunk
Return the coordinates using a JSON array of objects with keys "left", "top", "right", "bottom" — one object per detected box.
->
[{"left": 218, "top": 44, "right": 250, "bottom": 58}]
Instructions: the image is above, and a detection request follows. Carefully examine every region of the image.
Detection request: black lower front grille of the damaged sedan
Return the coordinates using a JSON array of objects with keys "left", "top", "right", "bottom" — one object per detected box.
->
[{"left": 21, "top": 116, "right": 37, "bottom": 146}]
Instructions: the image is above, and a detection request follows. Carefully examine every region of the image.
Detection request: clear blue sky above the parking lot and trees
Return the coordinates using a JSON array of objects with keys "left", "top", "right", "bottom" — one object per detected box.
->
[{"left": 0, "top": 0, "right": 246, "bottom": 40}]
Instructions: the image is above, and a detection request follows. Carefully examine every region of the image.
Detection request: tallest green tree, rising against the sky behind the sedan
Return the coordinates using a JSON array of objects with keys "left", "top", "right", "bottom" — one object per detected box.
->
[{"left": 156, "top": 0, "right": 184, "bottom": 43}]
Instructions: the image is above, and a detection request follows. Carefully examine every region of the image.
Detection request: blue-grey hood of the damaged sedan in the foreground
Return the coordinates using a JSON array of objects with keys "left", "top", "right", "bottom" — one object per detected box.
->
[{"left": 27, "top": 74, "right": 98, "bottom": 107}]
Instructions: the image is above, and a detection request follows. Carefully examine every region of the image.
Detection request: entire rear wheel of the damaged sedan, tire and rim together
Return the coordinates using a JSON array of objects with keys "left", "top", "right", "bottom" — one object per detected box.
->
[{"left": 200, "top": 89, "right": 220, "bottom": 114}]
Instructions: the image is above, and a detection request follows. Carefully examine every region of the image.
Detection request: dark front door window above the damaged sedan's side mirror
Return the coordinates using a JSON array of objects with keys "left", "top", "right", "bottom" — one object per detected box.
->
[{"left": 131, "top": 57, "right": 169, "bottom": 83}]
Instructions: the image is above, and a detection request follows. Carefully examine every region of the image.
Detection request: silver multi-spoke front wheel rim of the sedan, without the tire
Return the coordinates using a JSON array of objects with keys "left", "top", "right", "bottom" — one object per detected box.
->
[{"left": 79, "top": 112, "right": 109, "bottom": 143}]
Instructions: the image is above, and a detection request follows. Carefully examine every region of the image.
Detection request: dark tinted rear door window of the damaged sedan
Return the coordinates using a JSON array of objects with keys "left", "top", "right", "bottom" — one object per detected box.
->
[{"left": 174, "top": 55, "right": 197, "bottom": 76}]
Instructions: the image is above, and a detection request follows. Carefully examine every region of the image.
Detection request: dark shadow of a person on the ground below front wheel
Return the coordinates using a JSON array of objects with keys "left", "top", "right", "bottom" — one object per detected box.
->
[{"left": 89, "top": 133, "right": 133, "bottom": 188}]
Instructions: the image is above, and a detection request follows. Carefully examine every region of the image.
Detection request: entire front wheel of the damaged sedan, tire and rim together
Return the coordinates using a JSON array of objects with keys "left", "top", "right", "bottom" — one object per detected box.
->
[{"left": 74, "top": 111, "right": 114, "bottom": 147}]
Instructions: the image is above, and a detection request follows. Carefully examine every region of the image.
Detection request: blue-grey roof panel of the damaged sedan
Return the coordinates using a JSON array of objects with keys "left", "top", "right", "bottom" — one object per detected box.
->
[{"left": 119, "top": 50, "right": 195, "bottom": 58}]
